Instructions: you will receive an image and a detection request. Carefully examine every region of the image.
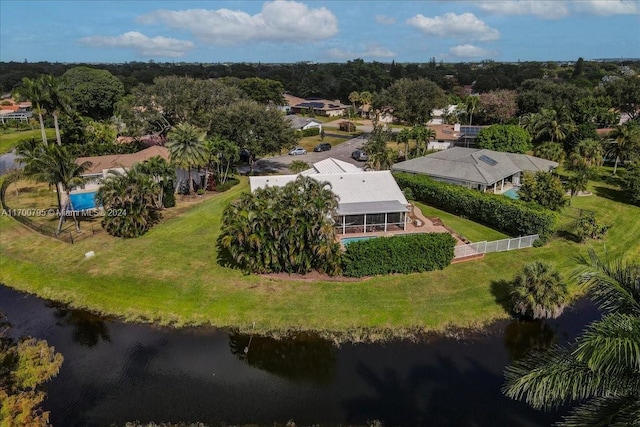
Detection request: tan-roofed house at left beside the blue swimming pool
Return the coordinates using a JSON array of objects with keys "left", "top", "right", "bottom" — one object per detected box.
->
[{"left": 72, "top": 145, "right": 169, "bottom": 193}]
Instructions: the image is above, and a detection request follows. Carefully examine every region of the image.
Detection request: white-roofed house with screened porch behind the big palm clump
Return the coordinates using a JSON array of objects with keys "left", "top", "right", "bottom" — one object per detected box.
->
[{"left": 249, "top": 159, "right": 409, "bottom": 234}]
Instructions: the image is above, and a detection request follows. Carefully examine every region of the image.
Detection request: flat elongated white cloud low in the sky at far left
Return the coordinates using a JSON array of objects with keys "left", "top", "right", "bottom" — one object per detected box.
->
[{"left": 80, "top": 31, "right": 194, "bottom": 58}]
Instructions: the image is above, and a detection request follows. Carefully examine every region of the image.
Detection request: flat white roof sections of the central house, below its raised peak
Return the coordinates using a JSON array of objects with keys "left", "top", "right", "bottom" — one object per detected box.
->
[{"left": 249, "top": 171, "right": 408, "bottom": 205}]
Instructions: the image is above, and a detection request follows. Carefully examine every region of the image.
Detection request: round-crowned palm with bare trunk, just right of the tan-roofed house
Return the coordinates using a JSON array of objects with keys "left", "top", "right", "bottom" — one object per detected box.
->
[{"left": 167, "top": 123, "right": 205, "bottom": 193}]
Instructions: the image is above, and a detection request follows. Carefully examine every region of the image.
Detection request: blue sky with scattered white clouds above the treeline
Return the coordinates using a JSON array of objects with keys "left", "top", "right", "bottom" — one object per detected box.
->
[{"left": 0, "top": 0, "right": 640, "bottom": 62}]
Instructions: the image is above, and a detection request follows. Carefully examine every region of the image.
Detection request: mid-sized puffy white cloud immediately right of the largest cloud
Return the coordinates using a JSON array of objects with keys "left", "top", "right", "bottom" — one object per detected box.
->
[{"left": 407, "top": 13, "right": 500, "bottom": 41}]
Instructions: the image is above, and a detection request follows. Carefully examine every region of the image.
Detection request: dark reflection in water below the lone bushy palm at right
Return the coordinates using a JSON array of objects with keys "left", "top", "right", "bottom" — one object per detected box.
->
[{"left": 504, "top": 320, "right": 558, "bottom": 360}]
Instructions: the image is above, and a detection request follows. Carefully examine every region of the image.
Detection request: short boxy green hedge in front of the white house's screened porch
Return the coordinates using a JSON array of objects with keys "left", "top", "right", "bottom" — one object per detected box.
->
[{"left": 342, "top": 233, "right": 456, "bottom": 277}]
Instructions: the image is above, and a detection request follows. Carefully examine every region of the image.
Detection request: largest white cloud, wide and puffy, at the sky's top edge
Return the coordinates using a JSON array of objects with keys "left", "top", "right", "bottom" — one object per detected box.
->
[{"left": 138, "top": 0, "right": 338, "bottom": 45}]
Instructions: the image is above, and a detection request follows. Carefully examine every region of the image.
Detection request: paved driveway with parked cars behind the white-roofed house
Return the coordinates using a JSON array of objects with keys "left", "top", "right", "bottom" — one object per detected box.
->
[{"left": 245, "top": 137, "right": 366, "bottom": 173}]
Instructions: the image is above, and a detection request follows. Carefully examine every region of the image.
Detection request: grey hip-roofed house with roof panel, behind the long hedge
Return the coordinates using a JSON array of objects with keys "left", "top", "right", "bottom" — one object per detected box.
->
[{"left": 391, "top": 147, "right": 558, "bottom": 193}]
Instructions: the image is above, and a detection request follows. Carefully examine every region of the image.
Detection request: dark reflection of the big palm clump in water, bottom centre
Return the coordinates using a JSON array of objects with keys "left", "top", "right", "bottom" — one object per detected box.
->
[{"left": 229, "top": 333, "right": 337, "bottom": 384}]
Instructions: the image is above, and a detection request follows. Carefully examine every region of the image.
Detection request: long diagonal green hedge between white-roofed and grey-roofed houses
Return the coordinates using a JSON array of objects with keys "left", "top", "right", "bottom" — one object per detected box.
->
[{"left": 395, "top": 173, "right": 558, "bottom": 241}]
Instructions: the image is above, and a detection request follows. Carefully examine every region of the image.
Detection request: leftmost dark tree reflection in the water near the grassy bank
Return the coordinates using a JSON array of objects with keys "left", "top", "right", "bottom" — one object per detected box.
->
[{"left": 46, "top": 302, "right": 111, "bottom": 347}]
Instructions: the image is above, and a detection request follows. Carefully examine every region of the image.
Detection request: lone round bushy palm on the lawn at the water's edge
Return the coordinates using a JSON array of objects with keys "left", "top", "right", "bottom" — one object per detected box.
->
[{"left": 509, "top": 261, "right": 569, "bottom": 319}]
